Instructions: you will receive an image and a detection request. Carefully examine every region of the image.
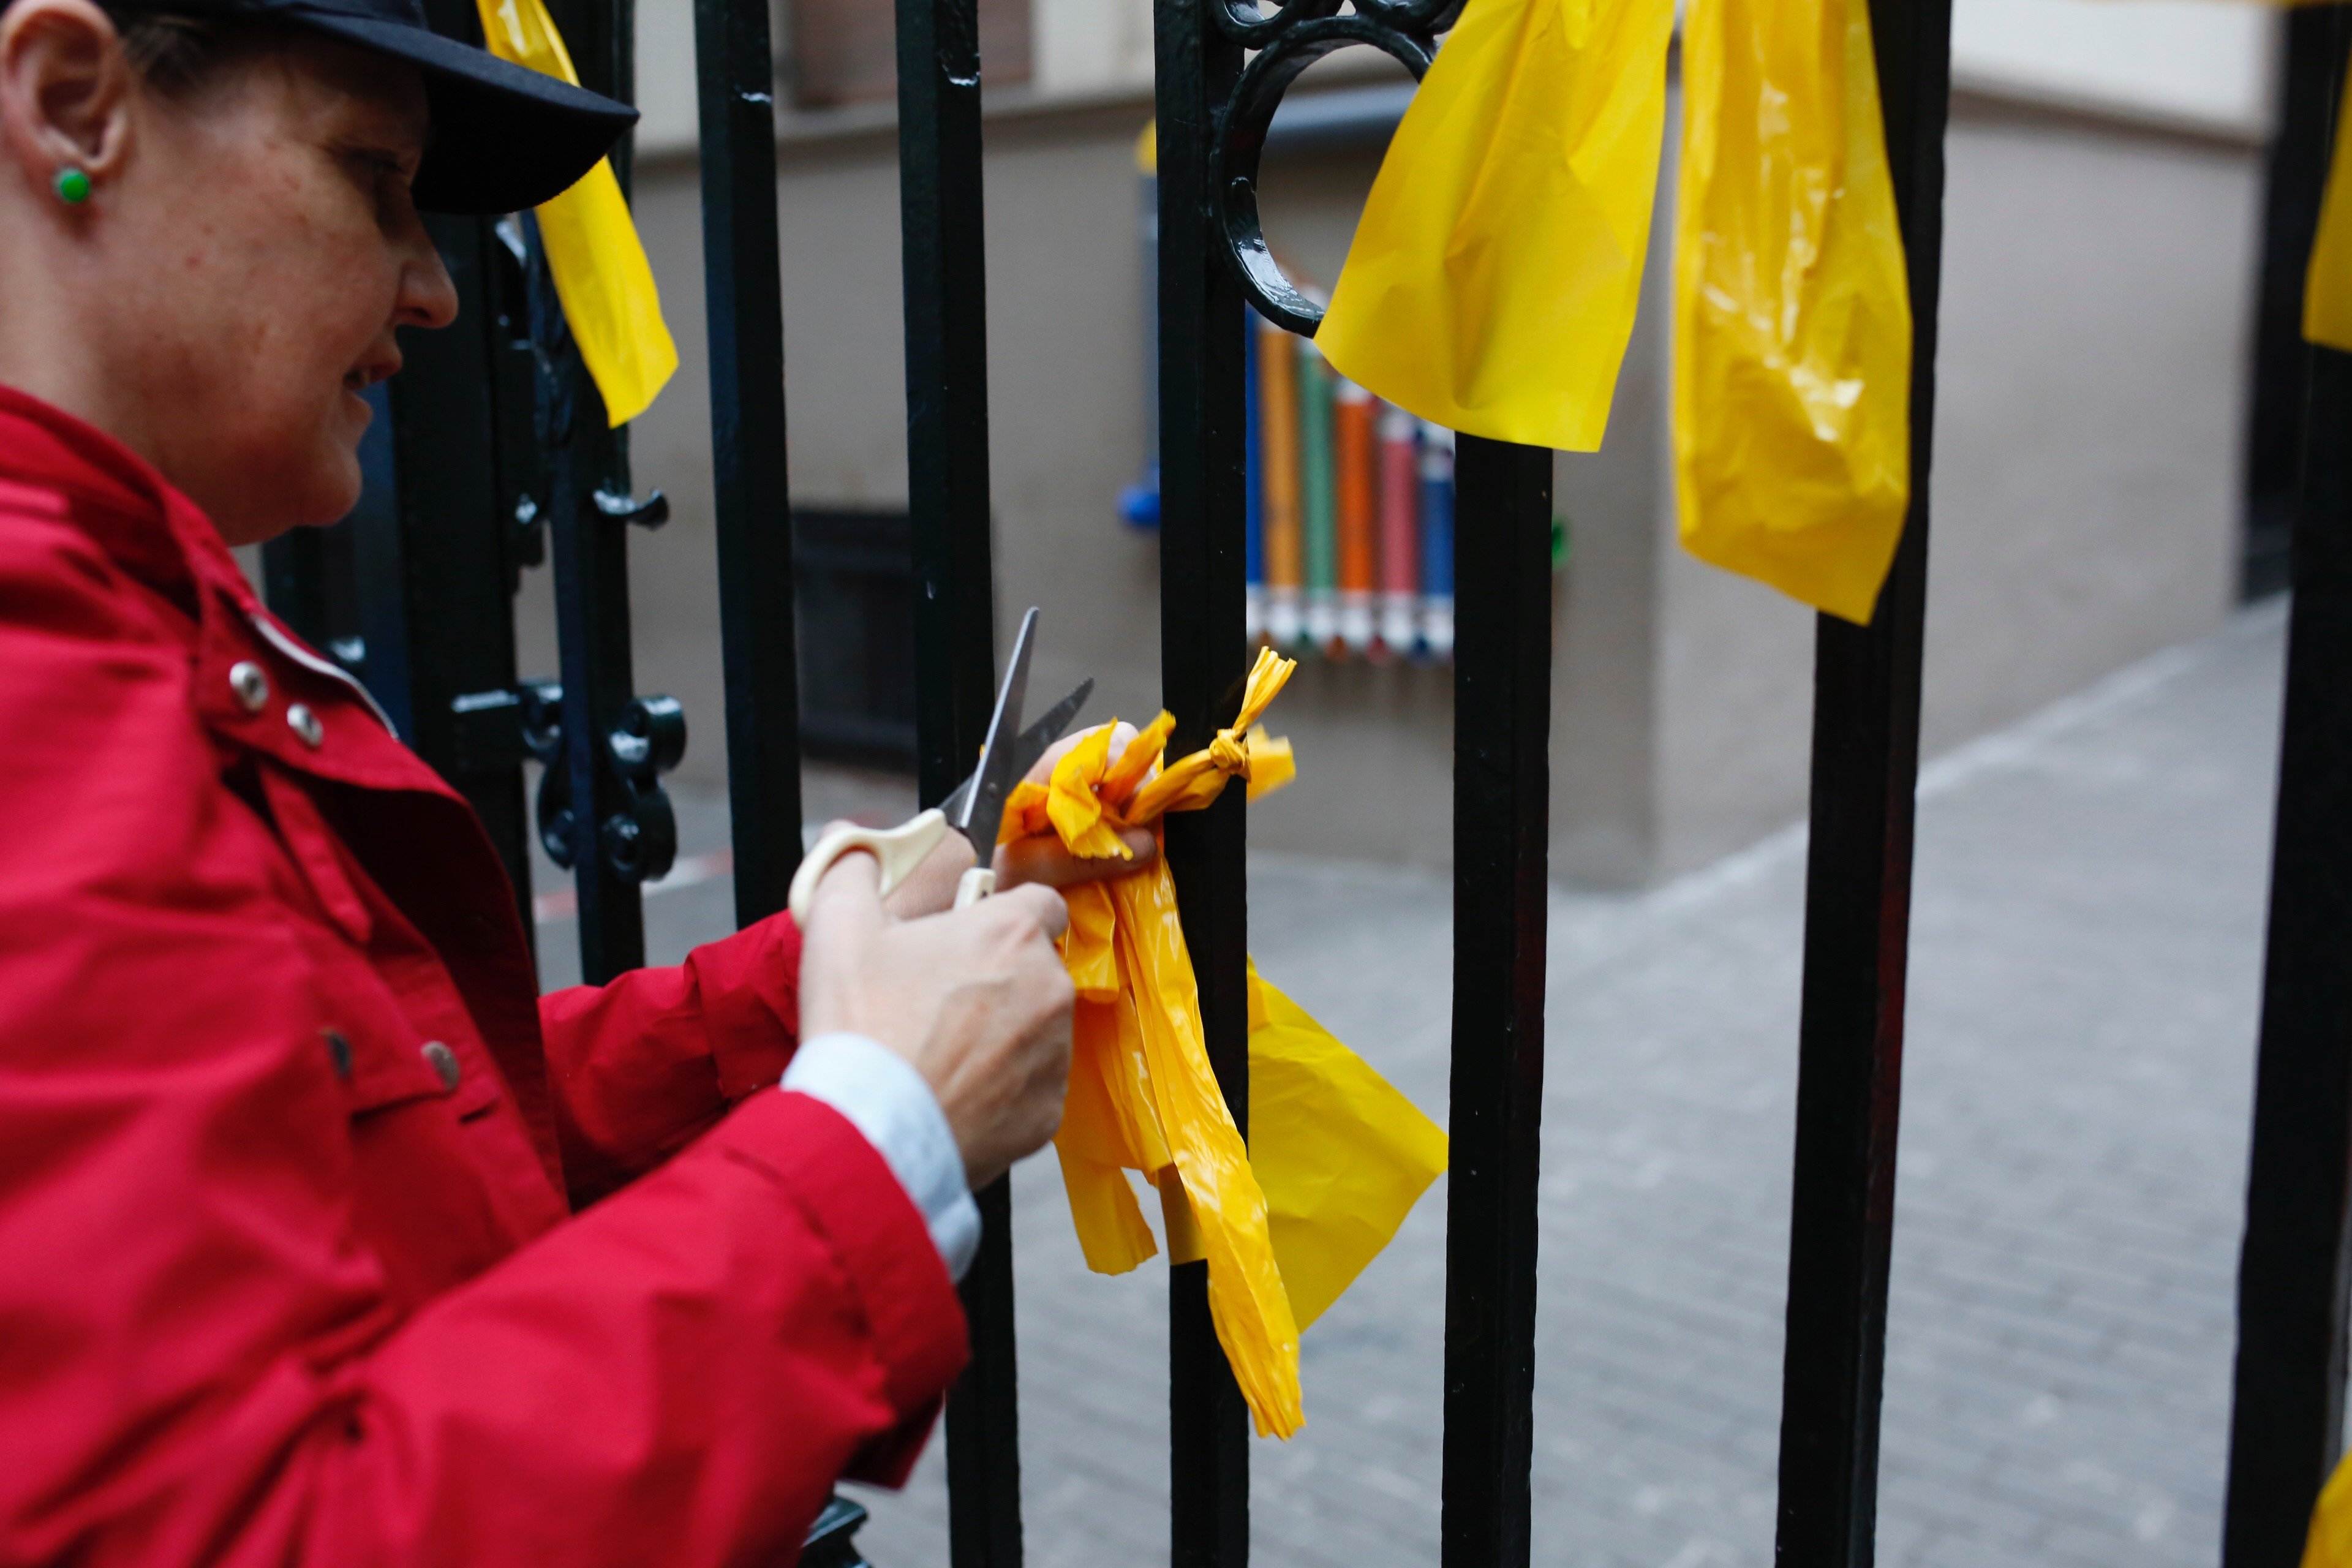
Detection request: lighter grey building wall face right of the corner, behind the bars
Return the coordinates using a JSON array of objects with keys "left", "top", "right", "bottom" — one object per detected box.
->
[{"left": 1646, "top": 104, "right": 2260, "bottom": 872}]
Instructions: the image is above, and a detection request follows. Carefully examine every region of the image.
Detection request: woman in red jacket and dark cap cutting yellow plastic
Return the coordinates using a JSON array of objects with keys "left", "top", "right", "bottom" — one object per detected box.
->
[{"left": 0, "top": 0, "right": 1148, "bottom": 1568}]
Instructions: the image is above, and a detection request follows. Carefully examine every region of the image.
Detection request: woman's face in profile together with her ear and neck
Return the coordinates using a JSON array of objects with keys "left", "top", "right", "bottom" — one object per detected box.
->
[{"left": 0, "top": 0, "right": 456, "bottom": 543}]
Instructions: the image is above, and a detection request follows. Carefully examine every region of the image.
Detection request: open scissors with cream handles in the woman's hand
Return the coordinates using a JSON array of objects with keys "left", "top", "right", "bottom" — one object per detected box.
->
[{"left": 786, "top": 609, "right": 1094, "bottom": 924}]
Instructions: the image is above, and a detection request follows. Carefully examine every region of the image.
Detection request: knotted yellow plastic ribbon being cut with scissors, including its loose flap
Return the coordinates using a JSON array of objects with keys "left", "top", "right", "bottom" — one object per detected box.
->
[{"left": 1002, "top": 649, "right": 1444, "bottom": 1436}]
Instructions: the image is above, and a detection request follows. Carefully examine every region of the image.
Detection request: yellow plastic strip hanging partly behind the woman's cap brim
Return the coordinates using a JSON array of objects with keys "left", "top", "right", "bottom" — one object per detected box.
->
[{"left": 475, "top": 0, "right": 677, "bottom": 426}]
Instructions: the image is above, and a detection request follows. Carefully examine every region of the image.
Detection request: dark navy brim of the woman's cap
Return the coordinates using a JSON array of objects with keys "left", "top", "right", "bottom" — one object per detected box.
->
[{"left": 268, "top": 5, "right": 638, "bottom": 211}]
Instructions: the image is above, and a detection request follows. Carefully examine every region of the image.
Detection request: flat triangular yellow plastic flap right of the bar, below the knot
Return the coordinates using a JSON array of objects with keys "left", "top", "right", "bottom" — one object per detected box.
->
[{"left": 1249, "top": 966, "right": 1447, "bottom": 1333}]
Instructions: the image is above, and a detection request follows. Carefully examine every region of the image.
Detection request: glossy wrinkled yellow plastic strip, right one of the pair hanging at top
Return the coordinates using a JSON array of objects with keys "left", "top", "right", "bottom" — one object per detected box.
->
[{"left": 1675, "top": 0, "right": 1912, "bottom": 623}]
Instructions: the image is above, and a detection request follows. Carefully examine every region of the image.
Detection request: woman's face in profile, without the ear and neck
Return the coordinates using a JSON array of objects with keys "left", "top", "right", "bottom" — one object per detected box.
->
[{"left": 119, "top": 37, "right": 456, "bottom": 543}]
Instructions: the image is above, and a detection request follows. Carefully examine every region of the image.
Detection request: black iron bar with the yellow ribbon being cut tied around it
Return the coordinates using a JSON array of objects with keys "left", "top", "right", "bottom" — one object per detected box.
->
[{"left": 1155, "top": 0, "right": 1249, "bottom": 1568}]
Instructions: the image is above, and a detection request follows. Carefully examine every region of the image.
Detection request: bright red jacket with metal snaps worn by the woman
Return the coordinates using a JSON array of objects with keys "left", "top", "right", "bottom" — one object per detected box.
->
[{"left": 0, "top": 388, "right": 964, "bottom": 1568}]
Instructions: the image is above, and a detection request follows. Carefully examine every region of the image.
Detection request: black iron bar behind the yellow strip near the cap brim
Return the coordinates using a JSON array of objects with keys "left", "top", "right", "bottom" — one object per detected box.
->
[{"left": 548, "top": 0, "right": 644, "bottom": 985}]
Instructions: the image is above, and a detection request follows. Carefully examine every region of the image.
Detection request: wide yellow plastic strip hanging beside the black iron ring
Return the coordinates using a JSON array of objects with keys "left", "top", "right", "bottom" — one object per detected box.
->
[{"left": 1315, "top": 0, "right": 1675, "bottom": 451}]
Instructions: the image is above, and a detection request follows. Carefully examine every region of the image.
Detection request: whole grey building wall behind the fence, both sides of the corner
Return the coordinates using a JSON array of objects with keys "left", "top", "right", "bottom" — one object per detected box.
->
[{"left": 527, "top": 92, "right": 2258, "bottom": 884}]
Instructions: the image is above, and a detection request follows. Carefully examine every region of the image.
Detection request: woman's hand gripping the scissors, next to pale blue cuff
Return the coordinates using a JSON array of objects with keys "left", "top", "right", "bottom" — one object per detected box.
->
[{"left": 800, "top": 851, "right": 1070, "bottom": 1189}]
